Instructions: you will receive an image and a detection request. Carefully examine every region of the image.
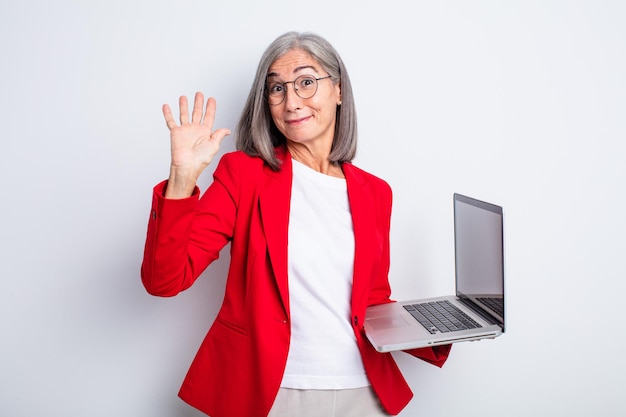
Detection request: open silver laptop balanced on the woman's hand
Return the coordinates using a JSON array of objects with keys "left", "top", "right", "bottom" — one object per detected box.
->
[{"left": 364, "top": 193, "right": 505, "bottom": 352}]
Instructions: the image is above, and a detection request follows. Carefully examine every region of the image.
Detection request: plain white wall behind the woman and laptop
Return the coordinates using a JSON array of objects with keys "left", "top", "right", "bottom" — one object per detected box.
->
[{"left": 0, "top": 0, "right": 626, "bottom": 417}]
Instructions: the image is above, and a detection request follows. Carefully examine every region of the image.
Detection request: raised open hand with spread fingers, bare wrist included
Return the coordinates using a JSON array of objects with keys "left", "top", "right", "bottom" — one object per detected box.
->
[{"left": 163, "top": 92, "right": 230, "bottom": 198}]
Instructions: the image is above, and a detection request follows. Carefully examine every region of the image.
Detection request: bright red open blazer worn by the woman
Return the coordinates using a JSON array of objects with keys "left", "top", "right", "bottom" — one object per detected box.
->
[{"left": 141, "top": 149, "right": 450, "bottom": 417}]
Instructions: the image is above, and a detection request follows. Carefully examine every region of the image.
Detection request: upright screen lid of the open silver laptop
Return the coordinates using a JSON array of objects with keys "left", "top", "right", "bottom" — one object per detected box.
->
[{"left": 454, "top": 194, "right": 504, "bottom": 328}]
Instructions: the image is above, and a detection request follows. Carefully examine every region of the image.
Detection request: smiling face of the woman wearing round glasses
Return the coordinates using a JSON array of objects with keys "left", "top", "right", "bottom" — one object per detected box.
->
[{"left": 267, "top": 49, "right": 341, "bottom": 154}]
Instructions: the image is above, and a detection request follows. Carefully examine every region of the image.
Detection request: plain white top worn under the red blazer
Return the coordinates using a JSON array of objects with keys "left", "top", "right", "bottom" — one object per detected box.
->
[{"left": 281, "top": 161, "right": 369, "bottom": 389}]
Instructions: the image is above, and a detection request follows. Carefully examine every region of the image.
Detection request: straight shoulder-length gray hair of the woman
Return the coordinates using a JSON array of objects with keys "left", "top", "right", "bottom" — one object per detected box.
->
[{"left": 236, "top": 32, "right": 357, "bottom": 171}]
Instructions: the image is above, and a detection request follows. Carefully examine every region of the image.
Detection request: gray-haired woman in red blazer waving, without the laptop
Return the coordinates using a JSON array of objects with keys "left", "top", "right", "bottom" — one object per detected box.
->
[{"left": 141, "top": 32, "right": 449, "bottom": 417}]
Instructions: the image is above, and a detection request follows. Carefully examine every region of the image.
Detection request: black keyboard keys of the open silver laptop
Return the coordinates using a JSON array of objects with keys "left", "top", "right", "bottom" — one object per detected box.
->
[{"left": 404, "top": 300, "right": 482, "bottom": 334}]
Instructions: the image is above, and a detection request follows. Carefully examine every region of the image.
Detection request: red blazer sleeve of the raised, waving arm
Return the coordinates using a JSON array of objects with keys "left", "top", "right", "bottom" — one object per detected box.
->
[{"left": 141, "top": 157, "right": 237, "bottom": 297}]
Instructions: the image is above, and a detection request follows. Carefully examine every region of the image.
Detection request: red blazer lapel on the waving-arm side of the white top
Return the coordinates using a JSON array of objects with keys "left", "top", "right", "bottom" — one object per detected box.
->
[{"left": 259, "top": 149, "right": 292, "bottom": 317}]
